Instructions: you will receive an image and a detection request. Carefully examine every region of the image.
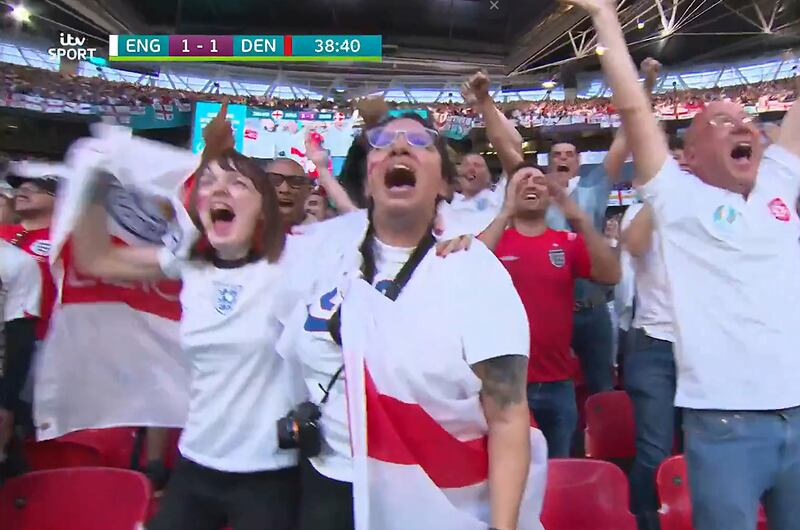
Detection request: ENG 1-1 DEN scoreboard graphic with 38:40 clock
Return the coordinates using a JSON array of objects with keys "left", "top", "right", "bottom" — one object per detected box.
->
[{"left": 108, "top": 35, "right": 383, "bottom": 62}]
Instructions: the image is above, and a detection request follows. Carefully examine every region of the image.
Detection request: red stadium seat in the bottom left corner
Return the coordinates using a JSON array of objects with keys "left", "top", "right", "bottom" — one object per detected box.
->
[{"left": 0, "top": 467, "right": 151, "bottom": 530}]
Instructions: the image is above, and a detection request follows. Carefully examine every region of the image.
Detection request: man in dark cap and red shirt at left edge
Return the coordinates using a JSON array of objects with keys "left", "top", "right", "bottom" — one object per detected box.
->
[{"left": 0, "top": 174, "right": 58, "bottom": 340}]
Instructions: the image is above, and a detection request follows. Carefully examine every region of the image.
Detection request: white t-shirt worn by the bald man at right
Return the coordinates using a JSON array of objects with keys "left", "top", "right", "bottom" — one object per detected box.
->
[{"left": 640, "top": 145, "right": 800, "bottom": 410}]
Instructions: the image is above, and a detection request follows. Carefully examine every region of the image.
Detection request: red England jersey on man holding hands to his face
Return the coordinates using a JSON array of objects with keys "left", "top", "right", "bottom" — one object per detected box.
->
[{"left": 495, "top": 228, "right": 592, "bottom": 383}]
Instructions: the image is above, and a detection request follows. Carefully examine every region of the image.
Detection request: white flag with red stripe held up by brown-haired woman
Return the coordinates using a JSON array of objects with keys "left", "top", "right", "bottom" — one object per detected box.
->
[{"left": 34, "top": 126, "right": 199, "bottom": 439}]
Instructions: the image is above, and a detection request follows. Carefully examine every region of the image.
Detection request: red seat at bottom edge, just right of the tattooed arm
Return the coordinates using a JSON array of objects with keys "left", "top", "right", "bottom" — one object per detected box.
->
[{"left": 542, "top": 458, "right": 636, "bottom": 530}]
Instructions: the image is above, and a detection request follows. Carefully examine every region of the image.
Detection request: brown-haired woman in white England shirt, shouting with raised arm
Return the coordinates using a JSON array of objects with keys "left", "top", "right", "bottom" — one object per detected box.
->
[{"left": 73, "top": 104, "right": 302, "bottom": 530}]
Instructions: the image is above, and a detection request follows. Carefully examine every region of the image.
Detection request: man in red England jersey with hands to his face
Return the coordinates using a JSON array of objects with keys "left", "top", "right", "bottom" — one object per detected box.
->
[{"left": 479, "top": 164, "right": 621, "bottom": 458}]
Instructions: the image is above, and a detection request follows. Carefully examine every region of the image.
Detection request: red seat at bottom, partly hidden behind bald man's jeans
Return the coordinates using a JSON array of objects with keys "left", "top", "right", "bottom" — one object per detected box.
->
[{"left": 656, "top": 455, "right": 767, "bottom": 530}]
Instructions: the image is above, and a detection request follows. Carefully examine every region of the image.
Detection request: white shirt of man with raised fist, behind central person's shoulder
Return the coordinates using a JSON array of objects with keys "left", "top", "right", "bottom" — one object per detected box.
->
[{"left": 439, "top": 185, "right": 505, "bottom": 239}]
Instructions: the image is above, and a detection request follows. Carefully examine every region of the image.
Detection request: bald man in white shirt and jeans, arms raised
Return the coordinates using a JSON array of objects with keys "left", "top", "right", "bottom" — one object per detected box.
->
[{"left": 568, "top": 0, "right": 800, "bottom": 530}]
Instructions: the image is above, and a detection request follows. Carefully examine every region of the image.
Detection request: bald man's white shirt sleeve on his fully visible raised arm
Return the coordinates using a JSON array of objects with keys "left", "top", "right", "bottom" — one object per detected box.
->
[{"left": 637, "top": 157, "right": 707, "bottom": 226}]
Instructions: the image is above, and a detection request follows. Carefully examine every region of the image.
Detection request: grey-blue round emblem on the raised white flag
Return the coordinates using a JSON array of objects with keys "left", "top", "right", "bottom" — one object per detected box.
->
[{"left": 106, "top": 179, "right": 168, "bottom": 244}]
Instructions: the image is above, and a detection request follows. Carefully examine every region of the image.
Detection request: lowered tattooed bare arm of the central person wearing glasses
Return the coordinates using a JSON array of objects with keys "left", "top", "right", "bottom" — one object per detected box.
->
[{"left": 473, "top": 355, "right": 531, "bottom": 530}]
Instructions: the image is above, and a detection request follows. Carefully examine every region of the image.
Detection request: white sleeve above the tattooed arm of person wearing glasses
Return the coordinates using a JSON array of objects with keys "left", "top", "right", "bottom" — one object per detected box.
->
[{"left": 445, "top": 241, "right": 530, "bottom": 365}]
